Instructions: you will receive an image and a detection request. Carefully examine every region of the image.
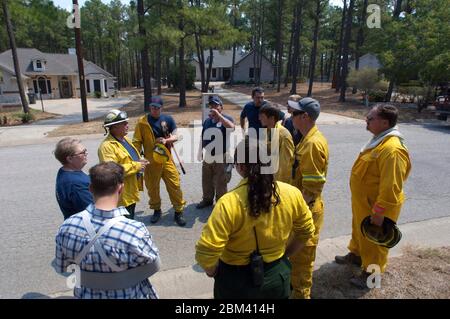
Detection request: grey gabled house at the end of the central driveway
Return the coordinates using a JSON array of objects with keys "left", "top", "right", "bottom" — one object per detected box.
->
[{"left": 192, "top": 50, "right": 275, "bottom": 82}]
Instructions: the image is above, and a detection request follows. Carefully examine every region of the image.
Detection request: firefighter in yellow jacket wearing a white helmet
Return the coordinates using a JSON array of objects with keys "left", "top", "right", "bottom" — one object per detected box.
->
[{"left": 98, "top": 110, "right": 148, "bottom": 219}]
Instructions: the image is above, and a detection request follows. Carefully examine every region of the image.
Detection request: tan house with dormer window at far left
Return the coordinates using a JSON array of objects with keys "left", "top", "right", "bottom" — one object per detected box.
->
[{"left": 0, "top": 49, "right": 115, "bottom": 102}]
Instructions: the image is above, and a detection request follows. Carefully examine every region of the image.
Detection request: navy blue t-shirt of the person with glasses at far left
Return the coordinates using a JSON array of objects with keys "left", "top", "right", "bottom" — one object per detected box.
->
[{"left": 56, "top": 168, "right": 94, "bottom": 219}]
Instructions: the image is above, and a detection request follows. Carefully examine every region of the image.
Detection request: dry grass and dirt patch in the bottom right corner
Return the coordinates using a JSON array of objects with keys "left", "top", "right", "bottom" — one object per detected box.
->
[{"left": 311, "top": 246, "right": 450, "bottom": 299}]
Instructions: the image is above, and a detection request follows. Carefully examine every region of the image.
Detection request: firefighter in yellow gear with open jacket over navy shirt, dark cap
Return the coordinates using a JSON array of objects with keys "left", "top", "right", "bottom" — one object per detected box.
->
[{"left": 133, "top": 96, "right": 186, "bottom": 226}]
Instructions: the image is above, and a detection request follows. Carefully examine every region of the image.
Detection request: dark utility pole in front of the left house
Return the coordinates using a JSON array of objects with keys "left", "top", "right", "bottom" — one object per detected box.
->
[{"left": 72, "top": 0, "right": 89, "bottom": 122}]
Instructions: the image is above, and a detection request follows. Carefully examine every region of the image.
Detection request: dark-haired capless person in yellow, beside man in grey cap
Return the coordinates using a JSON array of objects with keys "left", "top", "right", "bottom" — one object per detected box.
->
[{"left": 259, "top": 103, "right": 294, "bottom": 183}]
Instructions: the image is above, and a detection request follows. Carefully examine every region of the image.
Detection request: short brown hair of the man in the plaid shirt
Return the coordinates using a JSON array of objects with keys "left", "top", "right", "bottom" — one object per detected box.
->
[{"left": 89, "top": 162, "right": 125, "bottom": 197}]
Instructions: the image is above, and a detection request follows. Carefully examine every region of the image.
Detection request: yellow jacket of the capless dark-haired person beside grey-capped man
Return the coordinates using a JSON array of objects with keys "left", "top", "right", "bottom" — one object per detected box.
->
[{"left": 275, "top": 121, "right": 295, "bottom": 183}]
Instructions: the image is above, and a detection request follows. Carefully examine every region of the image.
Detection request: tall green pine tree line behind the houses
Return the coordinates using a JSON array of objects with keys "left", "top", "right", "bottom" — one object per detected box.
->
[{"left": 0, "top": 0, "right": 450, "bottom": 107}]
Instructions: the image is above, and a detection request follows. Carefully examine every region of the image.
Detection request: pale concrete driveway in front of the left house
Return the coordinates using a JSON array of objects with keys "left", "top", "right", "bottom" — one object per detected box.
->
[{"left": 0, "top": 96, "right": 133, "bottom": 146}]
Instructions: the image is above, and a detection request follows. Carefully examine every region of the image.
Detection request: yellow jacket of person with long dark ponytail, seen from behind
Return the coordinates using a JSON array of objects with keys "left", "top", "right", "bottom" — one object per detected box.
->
[{"left": 195, "top": 178, "right": 314, "bottom": 268}]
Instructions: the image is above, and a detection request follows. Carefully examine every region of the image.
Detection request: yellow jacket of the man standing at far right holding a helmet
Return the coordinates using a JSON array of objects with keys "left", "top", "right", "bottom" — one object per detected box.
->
[{"left": 350, "top": 136, "right": 411, "bottom": 221}]
